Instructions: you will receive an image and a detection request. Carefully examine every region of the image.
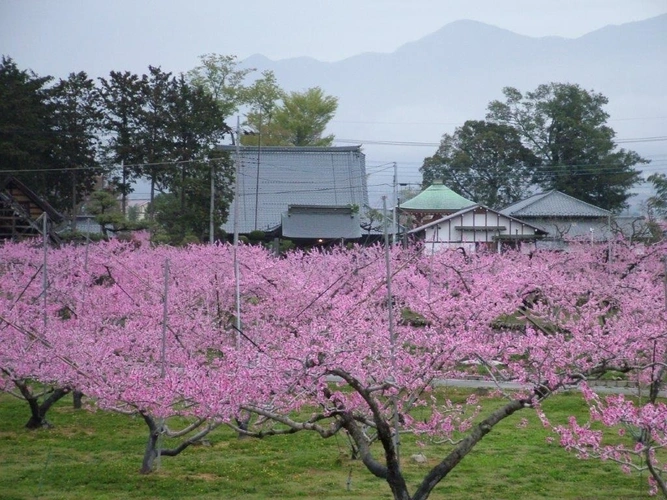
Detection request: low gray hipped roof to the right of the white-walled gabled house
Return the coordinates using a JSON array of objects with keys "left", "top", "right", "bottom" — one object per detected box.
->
[{"left": 500, "top": 190, "right": 611, "bottom": 218}]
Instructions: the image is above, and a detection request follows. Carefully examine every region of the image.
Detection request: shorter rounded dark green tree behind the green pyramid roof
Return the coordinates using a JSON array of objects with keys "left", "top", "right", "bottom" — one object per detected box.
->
[{"left": 420, "top": 120, "right": 538, "bottom": 208}]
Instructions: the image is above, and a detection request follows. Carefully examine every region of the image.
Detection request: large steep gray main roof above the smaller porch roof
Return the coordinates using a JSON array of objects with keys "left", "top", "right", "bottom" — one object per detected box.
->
[{"left": 219, "top": 146, "right": 368, "bottom": 233}]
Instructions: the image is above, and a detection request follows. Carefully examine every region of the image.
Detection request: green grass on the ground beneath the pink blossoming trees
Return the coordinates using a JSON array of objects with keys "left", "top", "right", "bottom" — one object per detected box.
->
[{"left": 0, "top": 394, "right": 649, "bottom": 500}]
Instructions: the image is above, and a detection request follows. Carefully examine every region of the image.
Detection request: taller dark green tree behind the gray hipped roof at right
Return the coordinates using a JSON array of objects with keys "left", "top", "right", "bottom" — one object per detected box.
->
[{"left": 487, "top": 83, "right": 647, "bottom": 211}]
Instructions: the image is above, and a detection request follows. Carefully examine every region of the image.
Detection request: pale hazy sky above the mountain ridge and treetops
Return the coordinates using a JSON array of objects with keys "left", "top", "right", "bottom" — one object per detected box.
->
[{"left": 0, "top": 0, "right": 667, "bottom": 77}]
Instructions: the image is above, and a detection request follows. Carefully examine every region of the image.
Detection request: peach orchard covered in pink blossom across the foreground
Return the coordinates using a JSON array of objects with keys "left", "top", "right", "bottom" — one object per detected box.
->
[{"left": 0, "top": 235, "right": 667, "bottom": 499}]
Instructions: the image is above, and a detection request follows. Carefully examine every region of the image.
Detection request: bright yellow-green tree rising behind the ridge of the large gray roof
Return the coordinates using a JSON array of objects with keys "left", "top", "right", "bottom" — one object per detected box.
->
[{"left": 262, "top": 87, "right": 338, "bottom": 146}]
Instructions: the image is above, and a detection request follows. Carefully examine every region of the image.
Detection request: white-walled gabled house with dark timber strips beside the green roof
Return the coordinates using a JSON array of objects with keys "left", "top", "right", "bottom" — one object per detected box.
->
[{"left": 409, "top": 204, "right": 547, "bottom": 254}]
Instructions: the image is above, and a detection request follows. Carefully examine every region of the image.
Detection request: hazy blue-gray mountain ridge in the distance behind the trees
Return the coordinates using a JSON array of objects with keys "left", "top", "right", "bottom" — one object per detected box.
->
[{"left": 244, "top": 15, "right": 667, "bottom": 211}]
